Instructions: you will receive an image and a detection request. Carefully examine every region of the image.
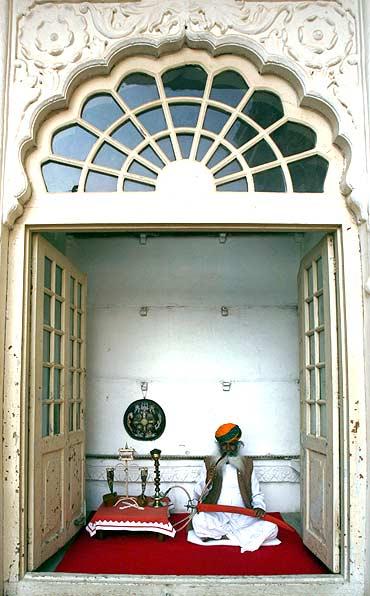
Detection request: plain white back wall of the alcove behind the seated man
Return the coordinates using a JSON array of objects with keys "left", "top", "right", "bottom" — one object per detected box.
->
[{"left": 67, "top": 234, "right": 302, "bottom": 511}]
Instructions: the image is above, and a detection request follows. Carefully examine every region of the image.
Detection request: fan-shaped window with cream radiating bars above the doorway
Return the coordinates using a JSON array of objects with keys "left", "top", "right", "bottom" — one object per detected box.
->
[{"left": 41, "top": 64, "right": 329, "bottom": 193}]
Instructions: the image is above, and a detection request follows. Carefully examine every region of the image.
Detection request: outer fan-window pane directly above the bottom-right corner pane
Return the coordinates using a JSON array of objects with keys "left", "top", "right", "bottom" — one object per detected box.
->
[{"left": 271, "top": 122, "right": 316, "bottom": 157}]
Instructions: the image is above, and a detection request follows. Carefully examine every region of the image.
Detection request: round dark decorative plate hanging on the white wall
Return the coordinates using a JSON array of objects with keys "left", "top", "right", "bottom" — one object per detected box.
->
[{"left": 123, "top": 398, "right": 166, "bottom": 441}]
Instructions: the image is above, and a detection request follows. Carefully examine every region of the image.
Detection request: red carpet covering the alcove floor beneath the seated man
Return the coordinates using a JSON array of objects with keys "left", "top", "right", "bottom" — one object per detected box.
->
[{"left": 56, "top": 513, "right": 328, "bottom": 575}]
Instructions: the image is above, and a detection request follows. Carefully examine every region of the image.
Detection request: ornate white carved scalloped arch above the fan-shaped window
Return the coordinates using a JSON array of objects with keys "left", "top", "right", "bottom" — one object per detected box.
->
[{"left": 4, "top": 0, "right": 366, "bottom": 226}]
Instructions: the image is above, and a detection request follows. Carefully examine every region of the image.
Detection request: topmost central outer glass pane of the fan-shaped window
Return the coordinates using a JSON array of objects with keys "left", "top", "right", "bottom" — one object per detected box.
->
[{"left": 162, "top": 65, "right": 207, "bottom": 97}]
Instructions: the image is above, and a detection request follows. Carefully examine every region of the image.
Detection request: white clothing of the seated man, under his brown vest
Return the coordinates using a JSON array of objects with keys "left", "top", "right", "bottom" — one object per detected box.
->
[{"left": 188, "top": 463, "right": 280, "bottom": 553}]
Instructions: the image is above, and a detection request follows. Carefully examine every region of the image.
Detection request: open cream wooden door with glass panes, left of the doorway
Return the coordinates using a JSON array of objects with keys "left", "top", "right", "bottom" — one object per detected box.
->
[{"left": 28, "top": 235, "right": 86, "bottom": 569}]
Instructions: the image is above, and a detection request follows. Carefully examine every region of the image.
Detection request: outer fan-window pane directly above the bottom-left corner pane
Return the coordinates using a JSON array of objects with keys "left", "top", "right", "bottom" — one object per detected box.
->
[{"left": 51, "top": 124, "right": 98, "bottom": 161}]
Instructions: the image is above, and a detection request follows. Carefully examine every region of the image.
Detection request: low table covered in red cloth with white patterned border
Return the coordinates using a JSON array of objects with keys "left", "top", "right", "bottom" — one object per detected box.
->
[{"left": 86, "top": 497, "right": 176, "bottom": 538}]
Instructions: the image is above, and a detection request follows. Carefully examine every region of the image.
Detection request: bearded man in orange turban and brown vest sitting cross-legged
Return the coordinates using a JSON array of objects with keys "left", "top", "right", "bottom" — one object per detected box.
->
[{"left": 188, "top": 423, "right": 280, "bottom": 553}]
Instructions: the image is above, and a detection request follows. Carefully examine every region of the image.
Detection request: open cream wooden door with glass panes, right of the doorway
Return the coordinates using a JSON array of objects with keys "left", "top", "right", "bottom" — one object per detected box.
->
[{"left": 298, "top": 235, "right": 340, "bottom": 573}]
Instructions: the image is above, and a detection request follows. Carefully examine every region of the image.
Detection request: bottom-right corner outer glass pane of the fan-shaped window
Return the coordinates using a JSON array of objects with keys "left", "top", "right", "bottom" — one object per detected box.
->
[{"left": 288, "top": 155, "right": 329, "bottom": 192}]
